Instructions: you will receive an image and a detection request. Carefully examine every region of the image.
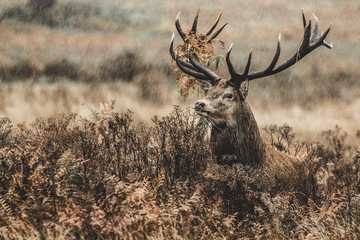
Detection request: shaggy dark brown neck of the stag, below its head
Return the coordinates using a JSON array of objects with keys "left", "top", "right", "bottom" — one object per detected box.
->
[{"left": 211, "top": 101, "right": 265, "bottom": 165}]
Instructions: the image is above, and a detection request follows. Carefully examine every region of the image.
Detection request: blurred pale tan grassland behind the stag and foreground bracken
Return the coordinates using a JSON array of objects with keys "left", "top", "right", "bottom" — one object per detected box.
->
[{"left": 0, "top": 0, "right": 360, "bottom": 141}]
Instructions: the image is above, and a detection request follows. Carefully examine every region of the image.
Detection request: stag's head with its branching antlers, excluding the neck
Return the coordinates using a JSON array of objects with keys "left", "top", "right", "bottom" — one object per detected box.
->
[{"left": 170, "top": 9, "right": 332, "bottom": 128}]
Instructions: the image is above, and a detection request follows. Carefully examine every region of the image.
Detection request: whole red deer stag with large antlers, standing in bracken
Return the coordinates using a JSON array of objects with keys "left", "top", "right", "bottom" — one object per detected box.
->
[{"left": 170, "top": 9, "right": 332, "bottom": 188}]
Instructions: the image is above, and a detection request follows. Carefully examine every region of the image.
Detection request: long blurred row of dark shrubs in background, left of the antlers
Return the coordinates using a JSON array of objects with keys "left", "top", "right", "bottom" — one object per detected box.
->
[{"left": 0, "top": 54, "right": 172, "bottom": 83}]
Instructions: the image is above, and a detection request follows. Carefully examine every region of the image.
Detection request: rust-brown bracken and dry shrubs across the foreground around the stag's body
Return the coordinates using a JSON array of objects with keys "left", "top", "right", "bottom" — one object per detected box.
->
[{"left": 0, "top": 108, "right": 360, "bottom": 239}]
